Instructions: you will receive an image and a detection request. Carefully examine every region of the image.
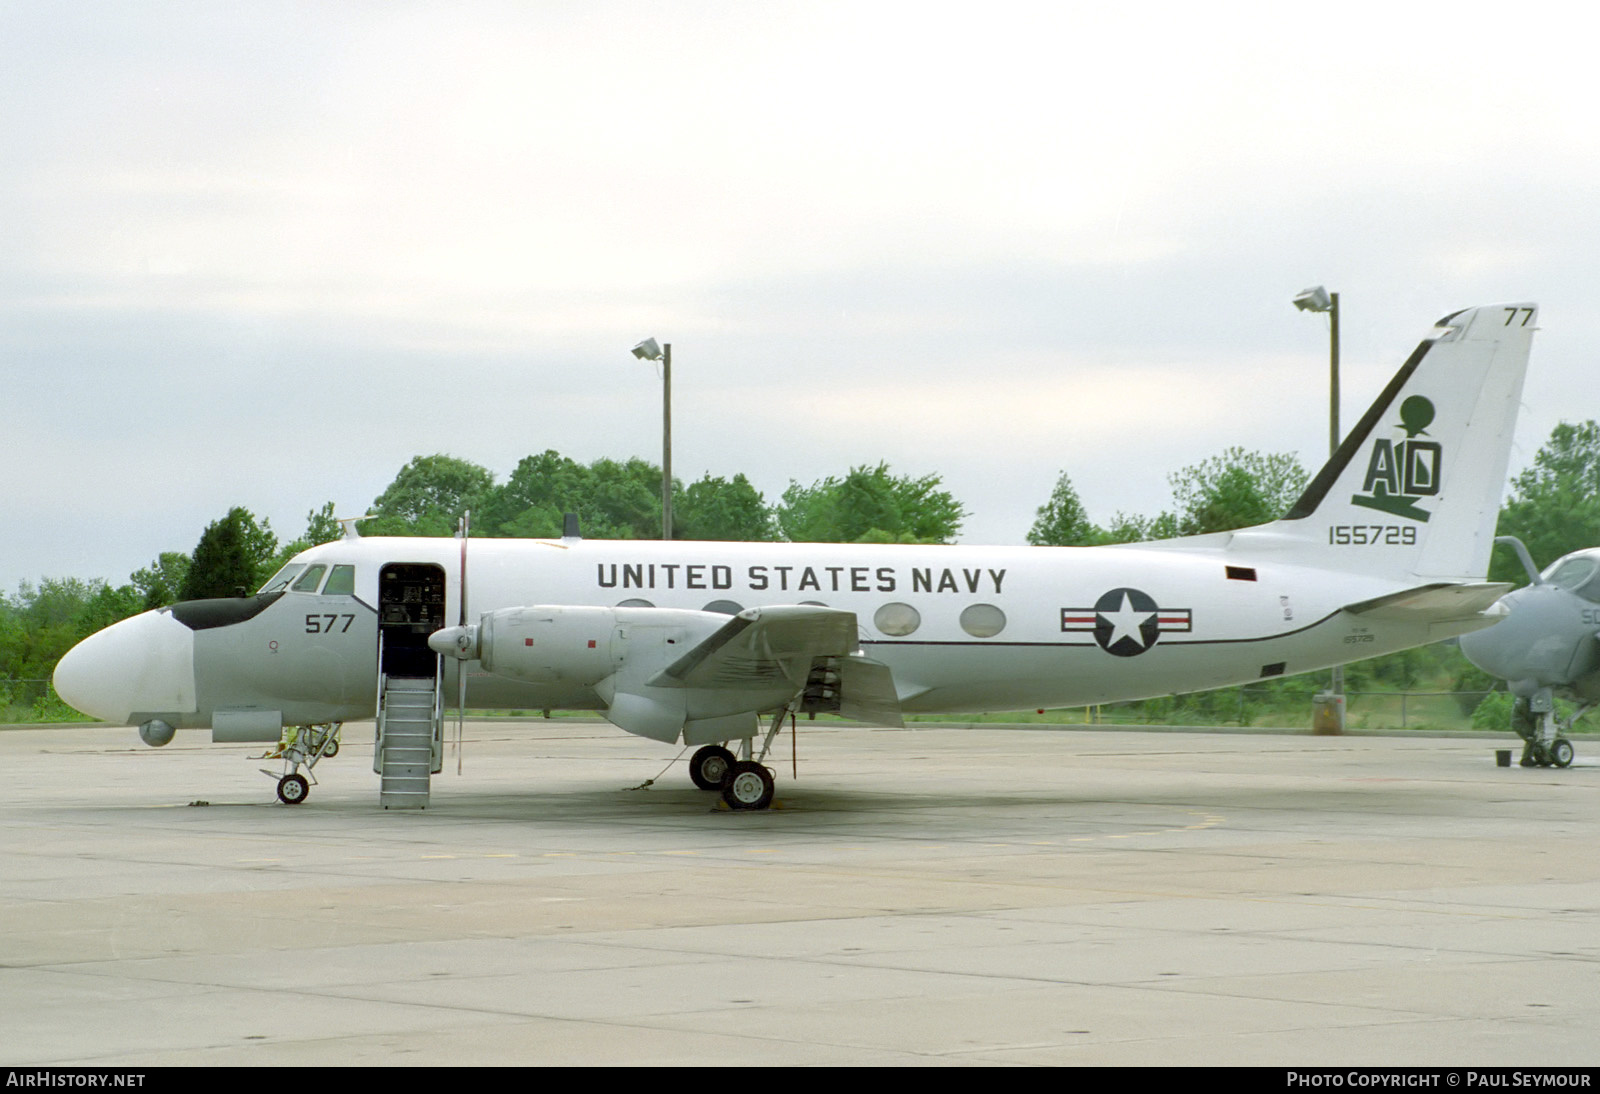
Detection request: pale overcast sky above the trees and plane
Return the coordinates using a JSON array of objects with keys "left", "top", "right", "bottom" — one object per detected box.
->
[{"left": 0, "top": 0, "right": 1600, "bottom": 592}]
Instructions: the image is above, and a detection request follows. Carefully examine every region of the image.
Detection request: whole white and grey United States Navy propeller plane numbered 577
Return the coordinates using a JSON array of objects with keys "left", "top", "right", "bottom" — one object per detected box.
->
[{"left": 54, "top": 304, "right": 1536, "bottom": 809}]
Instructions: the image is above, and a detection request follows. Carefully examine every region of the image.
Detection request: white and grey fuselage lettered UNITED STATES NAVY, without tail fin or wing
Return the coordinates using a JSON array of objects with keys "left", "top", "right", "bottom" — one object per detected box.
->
[{"left": 67, "top": 537, "right": 1470, "bottom": 736}]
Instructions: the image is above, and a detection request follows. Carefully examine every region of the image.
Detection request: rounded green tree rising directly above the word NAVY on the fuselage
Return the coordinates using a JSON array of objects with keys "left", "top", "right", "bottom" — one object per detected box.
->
[{"left": 776, "top": 464, "right": 966, "bottom": 544}]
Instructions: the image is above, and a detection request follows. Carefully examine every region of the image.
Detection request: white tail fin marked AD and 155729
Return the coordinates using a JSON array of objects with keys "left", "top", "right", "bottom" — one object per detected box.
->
[{"left": 1230, "top": 304, "right": 1538, "bottom": 581}]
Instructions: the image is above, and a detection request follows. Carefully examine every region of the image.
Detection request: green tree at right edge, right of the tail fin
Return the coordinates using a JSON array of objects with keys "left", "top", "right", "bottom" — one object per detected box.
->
[{"left": 1490, "top": 421, "right": 1600, "bottom": 585}]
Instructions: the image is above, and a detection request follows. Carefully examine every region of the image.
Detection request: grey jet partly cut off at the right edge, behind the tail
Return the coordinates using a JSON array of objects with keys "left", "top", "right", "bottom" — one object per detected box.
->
[{"left": 1461, "top": 536, "right": 1600, "bottom": 768}]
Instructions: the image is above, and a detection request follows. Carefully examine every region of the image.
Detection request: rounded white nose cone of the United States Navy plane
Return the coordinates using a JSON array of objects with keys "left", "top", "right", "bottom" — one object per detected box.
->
[{"left": 54, "top": 611, "right": 195, "bottom": 725}]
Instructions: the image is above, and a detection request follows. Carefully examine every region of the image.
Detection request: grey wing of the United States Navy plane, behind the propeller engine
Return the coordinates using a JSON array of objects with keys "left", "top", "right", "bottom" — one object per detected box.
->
[{"left": 650, "top": 605, "right": 861, "bottom": 689}]
